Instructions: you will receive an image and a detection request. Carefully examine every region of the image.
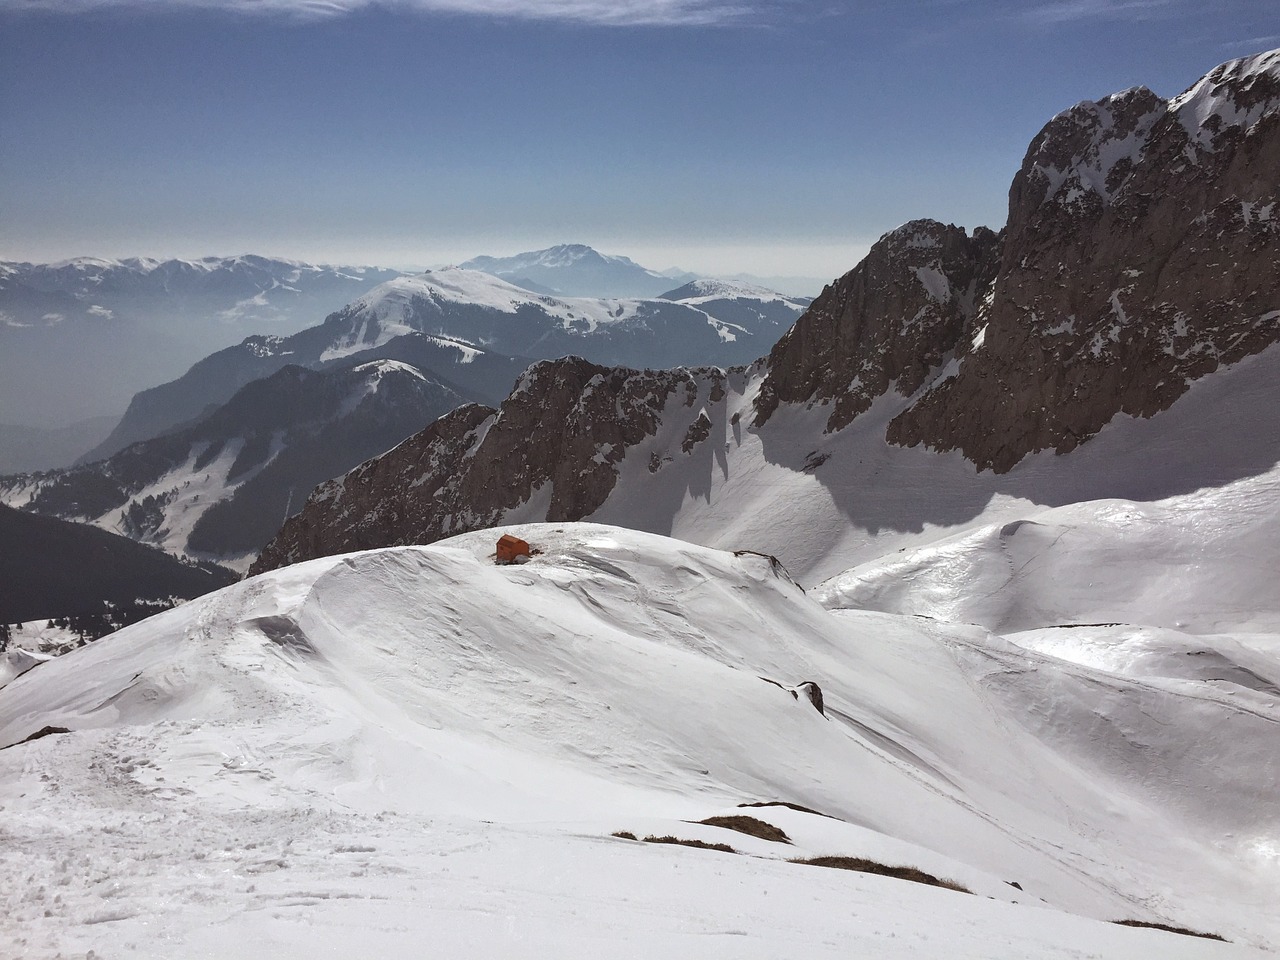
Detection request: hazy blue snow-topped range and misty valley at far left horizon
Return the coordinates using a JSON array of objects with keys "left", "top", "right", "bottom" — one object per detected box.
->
[{"left": 0, "top": 256, "right": 399, "bottom": 435}]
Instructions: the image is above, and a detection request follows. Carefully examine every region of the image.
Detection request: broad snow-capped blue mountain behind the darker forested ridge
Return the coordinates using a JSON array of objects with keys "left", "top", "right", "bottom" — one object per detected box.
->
[{"left": 83, "top": 268, "right": 804, "bottom": 462}]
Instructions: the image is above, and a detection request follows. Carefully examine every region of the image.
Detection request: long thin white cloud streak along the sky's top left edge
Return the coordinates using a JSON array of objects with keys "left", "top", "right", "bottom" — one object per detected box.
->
[{"left": 0, "top": 0, "right": 757, "bottom": 27}]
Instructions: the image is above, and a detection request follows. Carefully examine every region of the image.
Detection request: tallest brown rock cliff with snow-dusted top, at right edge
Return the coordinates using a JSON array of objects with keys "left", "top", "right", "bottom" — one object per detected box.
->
[{"left": 888, "top": 51, "right": 1280, "bottom": 471}]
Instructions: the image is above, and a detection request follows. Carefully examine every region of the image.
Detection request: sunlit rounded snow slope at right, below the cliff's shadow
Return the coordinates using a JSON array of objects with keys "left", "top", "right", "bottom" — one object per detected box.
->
[{"left": 817, "top": 474, "right": 1280, "bottom": 634}]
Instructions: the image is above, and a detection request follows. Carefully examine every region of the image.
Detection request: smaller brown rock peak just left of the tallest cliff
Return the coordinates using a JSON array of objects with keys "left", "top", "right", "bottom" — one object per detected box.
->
[{"left": 755, "top": 220, "right": 1000, "bottom": 430}]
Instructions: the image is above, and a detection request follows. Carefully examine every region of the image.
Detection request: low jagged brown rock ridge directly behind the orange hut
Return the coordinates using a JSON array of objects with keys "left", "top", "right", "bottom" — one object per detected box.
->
[{"left": 250, "top": 357, "right": 724, "bottom": 573}]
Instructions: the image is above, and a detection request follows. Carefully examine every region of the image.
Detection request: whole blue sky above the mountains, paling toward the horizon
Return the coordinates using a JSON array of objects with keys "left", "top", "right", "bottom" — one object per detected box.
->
[{"left": 0, "top": 0, "right": 1280, "bottom": 278}]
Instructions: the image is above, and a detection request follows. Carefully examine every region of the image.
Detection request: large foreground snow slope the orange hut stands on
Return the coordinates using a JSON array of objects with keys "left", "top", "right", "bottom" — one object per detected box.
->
[{"left": 0, "top": 525, "right": 1280, "bottom": 957}]
